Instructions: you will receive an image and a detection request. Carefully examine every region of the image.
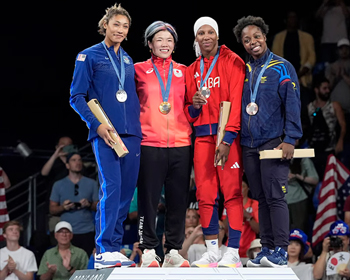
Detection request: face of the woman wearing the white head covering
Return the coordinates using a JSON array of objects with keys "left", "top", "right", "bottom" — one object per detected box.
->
[{"left": 196, "top": 25, "right": 219, "bottom": 58}]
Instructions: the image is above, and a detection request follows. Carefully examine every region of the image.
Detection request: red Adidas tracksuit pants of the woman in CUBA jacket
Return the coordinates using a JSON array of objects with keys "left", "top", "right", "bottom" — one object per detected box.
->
[{"left": 194, "top": 135, "right": 243, "bottom": 238}]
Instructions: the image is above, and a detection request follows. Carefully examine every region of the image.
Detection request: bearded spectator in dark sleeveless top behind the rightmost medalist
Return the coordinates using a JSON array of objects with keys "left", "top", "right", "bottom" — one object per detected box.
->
[{"left": 307, "top": 75, "right": 346, "bottom": 180}]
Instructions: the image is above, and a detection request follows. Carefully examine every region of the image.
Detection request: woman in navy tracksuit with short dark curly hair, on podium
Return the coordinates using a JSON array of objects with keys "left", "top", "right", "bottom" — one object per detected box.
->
[{"left": 234, "top": 16, "right": 302, "bottom": 267}]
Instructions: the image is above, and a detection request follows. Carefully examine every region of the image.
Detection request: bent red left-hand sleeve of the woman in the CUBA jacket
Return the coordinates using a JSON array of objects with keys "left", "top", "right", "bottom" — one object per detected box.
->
[{"left": 184, "top": 64, "right": 202, "bottom": 123}]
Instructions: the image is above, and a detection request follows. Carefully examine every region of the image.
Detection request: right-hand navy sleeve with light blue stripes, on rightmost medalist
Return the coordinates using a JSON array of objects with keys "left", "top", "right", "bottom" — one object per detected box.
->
[{"left": 278, "top": 62, "right": 303, "bottom": 145}]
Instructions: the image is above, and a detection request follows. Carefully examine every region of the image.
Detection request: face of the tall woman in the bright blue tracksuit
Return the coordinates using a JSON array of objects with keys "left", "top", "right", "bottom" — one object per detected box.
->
[{"left": 103, "top": 15, "right": 130, "bottom": 46}]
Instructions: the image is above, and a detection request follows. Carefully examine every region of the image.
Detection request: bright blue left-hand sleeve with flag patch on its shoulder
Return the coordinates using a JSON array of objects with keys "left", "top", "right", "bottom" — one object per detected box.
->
[{"left": 69, "top": 51, "right": 101, "bottom": 138}]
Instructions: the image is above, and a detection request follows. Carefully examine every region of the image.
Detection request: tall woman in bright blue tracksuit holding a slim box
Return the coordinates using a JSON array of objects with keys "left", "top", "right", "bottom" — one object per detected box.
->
[{"left": 70, "top": 2, "right": 142, "bottom": 268}]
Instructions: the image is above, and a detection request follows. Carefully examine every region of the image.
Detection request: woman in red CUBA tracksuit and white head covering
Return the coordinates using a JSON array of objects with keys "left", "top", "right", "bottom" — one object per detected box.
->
[{"left": 185, "top": 17, "right": 245, "bottom": 267}]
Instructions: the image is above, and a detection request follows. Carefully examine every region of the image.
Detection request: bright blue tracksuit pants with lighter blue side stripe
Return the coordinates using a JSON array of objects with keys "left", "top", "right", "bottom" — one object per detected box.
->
[{"left": 92, "top": 135, "right": 141, "bottom": 254}]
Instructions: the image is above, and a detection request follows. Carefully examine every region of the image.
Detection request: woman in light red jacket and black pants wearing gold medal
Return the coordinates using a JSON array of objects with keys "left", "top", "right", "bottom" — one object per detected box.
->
[{"left": 135, "top": 21, "right": 192, "bottom": 267}]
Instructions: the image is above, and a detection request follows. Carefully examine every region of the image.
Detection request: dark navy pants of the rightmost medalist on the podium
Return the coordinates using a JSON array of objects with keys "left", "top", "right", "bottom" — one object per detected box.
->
[{"left": 242, "top": 138, "right": 290, "bottom": 251}]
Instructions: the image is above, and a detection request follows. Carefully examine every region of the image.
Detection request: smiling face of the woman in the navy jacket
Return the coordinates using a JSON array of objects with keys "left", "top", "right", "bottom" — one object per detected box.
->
[{"left": 242, "top": 25, "right": 267, "bottom": 59}]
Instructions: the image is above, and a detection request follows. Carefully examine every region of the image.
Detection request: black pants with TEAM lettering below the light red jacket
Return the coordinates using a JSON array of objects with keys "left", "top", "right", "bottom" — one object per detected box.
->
[{"left": 137, "top": 146, "right": 191, "bottom": 253}]
